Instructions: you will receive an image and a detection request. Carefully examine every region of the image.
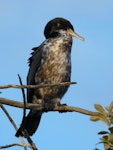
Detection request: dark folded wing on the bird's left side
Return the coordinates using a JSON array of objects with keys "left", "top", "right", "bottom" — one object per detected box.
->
[{"left": 27, "top": 47, "right": 42, "bottom": 102}]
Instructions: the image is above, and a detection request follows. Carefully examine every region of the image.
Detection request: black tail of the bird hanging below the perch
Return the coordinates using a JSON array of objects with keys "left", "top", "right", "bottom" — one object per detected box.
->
[{"left": 15, "top": 111, "right": 42, "bottom": 137}]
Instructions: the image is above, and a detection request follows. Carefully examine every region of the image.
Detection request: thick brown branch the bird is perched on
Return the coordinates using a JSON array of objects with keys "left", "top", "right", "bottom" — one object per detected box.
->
[{"left": 0, "top": 98, "right": 99, "bottom": 116}]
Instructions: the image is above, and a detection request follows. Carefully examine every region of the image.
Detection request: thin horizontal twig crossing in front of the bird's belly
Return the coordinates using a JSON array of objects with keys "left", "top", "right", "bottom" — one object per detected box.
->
[{"left": 0, "top": 82, "right": 77, "bottom": 89}]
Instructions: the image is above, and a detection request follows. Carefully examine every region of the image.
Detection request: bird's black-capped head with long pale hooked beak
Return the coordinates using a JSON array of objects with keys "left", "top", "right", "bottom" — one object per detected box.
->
[{"left": 44, "top": 18, "right": 84, "bottom": 41}]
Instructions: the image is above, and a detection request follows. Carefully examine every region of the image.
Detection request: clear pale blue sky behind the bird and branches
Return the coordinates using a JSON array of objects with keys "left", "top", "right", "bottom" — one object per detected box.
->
[{"left": 0, "top": 0, "right": 113, "bottom": 150}]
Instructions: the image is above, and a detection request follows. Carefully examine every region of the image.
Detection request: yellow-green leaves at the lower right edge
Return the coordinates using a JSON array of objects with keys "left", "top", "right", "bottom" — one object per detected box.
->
[{"left": 90, "top": 102, "right": 113, "bottom": 150}]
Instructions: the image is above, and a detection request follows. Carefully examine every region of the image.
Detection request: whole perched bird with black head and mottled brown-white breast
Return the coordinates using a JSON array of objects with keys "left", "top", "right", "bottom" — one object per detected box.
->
[{"left": 16, "top": 18, "right": 83, "bottom": 136}]
